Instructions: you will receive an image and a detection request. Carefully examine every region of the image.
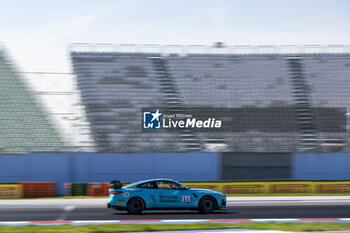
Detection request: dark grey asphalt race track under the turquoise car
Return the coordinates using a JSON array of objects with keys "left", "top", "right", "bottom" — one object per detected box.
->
[{"left": 0, "top": 202, "right": 350, "bottom": 221}]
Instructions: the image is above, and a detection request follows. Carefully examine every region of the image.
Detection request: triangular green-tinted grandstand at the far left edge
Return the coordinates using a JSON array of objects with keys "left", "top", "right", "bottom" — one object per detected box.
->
[{"left": 0, "top": 49, "right": 67, "bottom": 154}]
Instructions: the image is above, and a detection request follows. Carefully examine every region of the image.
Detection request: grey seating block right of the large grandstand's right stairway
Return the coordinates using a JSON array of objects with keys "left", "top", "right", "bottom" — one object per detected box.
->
[{"left": 303, "top": 54, "right": 350, "bottom": 146}]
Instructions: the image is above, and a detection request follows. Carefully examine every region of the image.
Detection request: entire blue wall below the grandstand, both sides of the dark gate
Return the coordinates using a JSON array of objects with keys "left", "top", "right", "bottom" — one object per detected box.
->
[{"left": 0, "top": 153, "right": 350, "bottom": 195}]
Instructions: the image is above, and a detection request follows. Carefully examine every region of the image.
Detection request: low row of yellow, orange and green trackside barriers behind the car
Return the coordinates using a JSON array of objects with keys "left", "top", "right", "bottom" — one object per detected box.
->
[{"left": 0, "top": 181, "right": 350, "bottom": 198}]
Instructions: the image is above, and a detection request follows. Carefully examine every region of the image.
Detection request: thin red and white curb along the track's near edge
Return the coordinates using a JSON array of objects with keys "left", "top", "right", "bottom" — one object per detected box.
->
[{"left": 0, "top": 218, "right": 350, "bottom": 226}]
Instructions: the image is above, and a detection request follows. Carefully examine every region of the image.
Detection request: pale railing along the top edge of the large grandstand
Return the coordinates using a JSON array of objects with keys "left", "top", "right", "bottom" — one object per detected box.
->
[{"left": 69, "top": 43, "right": 350, "bottom": 55}]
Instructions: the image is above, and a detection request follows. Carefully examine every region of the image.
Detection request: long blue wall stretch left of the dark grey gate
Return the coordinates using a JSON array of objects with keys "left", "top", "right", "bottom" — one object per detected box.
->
[{"left": 0, "top": 152, "right": 221, "bottom": 195}]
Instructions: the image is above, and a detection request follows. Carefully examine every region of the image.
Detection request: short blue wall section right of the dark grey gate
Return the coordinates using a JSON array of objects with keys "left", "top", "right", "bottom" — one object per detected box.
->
[{"left": 292, "top": 153, "right": 350, "bottom": 180}]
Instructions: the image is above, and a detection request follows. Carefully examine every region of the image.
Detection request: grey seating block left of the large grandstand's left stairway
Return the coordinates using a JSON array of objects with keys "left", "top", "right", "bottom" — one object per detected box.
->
[{"left": 72, "top": 53, "right": 184, "bottom": 151}]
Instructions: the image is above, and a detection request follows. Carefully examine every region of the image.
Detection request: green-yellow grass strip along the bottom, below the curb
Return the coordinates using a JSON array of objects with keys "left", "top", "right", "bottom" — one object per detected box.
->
[{"left": 0, "top": 222, "right": 350, "bottom": 233}]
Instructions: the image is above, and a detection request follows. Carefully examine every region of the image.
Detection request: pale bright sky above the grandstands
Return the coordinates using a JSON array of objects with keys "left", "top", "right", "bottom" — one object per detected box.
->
[{"left": 0, "top": 0, "right": 350, "bottom": 72}]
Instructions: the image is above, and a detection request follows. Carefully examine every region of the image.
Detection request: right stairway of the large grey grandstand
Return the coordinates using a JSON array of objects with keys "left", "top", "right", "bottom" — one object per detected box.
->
[{"left": 286, "top": 57, "right": 319, "bottom": 151}]
